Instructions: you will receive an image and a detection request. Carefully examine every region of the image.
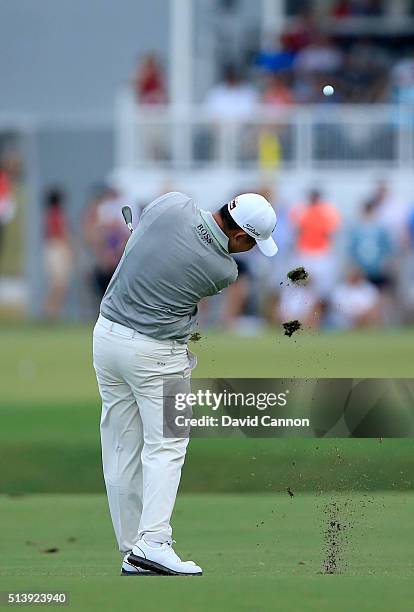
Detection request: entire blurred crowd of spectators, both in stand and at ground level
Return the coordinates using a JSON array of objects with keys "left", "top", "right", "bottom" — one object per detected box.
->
[{"left": 0, "top": 0, "right": 414, "bottom": 333}]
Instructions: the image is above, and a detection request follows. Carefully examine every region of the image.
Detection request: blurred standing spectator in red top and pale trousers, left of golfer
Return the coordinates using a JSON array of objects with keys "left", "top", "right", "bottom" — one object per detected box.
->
[{"left": 44, "top": 188, "right": 73, "bottom": 320}]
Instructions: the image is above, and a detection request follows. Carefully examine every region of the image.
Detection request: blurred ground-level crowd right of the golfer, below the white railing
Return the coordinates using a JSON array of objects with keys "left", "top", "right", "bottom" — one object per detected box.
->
[{"left": 206, "top": 182, "right": 414, "bottom": 333}]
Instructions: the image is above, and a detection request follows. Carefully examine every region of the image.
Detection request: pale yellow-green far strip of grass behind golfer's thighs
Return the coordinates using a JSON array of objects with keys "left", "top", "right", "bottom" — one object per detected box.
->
[{"left": 0, "top": 325, "right": 414, "bottom": 406}]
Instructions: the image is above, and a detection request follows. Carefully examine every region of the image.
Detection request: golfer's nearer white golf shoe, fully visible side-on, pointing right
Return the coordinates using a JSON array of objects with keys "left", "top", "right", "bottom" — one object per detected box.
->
[{"left": 128, "top": 539, "right": 203, "bottom": 576}]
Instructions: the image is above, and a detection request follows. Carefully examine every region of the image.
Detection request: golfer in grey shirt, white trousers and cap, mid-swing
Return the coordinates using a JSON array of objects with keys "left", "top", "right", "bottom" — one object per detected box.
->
[{"left": 93, "top": 192, "right": 277, "bottom": 576}]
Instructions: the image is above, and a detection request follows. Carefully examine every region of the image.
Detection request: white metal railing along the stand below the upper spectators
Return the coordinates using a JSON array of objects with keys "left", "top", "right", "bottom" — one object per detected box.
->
[{"left": 116, "top": 92, "right": 414, "bottom": 169}]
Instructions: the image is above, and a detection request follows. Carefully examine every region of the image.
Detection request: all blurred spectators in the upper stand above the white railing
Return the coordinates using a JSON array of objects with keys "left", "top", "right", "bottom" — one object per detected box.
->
[{"left": 133, "top": 8, "right": 414, "bottom": 112}]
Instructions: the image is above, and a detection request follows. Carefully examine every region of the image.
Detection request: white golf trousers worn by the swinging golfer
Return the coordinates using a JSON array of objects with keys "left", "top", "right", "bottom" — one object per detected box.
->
[{"left": 93, "top": 315, "right": 196, "bottom": 553}]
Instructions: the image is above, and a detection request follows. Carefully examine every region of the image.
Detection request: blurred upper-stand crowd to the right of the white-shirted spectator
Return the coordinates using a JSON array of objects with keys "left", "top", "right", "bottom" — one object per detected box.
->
[{"left": 251, "top": 6, "right": 414, "bottom": 106}]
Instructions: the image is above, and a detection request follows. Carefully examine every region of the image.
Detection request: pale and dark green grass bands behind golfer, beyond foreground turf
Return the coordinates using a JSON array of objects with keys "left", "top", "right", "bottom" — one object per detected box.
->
[{"left": 0, "top": 325, "right": 414, "bottom": 493}]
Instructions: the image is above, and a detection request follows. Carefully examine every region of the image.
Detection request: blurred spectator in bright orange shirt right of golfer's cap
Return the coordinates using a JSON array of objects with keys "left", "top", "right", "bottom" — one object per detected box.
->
[{"left": 291, "top": 189, "right": 341, "bottom": 298}]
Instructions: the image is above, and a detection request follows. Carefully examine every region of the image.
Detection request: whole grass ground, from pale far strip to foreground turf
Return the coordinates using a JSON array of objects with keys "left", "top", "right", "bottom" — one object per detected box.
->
[{"left": 0, "top": 325, "right": 414, "bottom": 612}]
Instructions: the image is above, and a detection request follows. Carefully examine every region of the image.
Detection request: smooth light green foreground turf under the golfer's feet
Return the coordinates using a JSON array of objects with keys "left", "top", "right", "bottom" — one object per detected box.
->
[{"left": 0, "top": 493, "right": 414, "bottom": 612}]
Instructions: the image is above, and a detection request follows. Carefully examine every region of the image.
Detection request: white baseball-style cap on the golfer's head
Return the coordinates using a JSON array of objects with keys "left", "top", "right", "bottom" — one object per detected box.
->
[{"left": 228, "top": 193, "right": 278, "bottom": 257}]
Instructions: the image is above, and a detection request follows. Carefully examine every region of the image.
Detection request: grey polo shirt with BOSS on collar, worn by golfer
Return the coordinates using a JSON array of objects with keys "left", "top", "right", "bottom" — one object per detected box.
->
[{"left": 101, "top": 192, "right": 237, "bottom": 342}]
